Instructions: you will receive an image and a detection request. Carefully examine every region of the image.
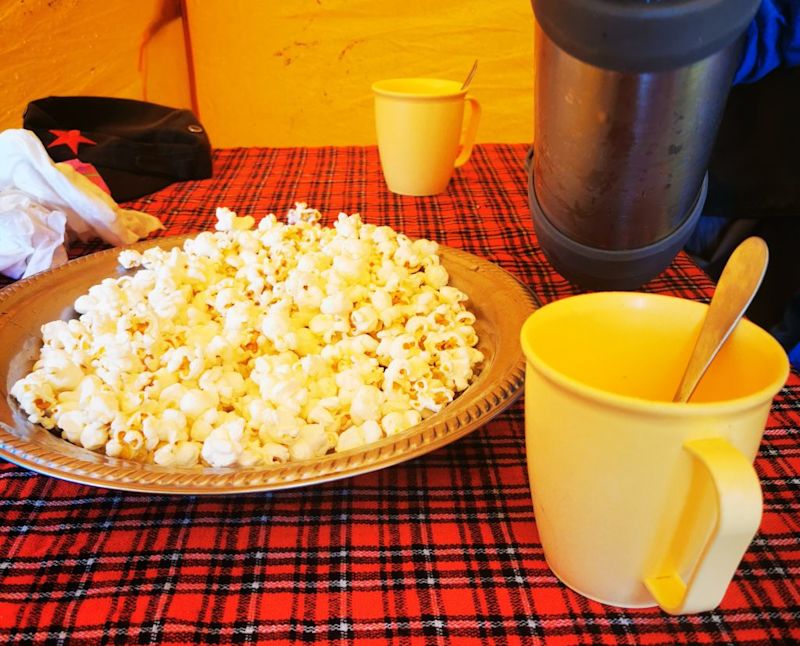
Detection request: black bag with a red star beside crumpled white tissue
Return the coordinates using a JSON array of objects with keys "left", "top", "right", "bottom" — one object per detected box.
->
[{"left": 22, "top": 96, "right": 211, "bottom": 202}]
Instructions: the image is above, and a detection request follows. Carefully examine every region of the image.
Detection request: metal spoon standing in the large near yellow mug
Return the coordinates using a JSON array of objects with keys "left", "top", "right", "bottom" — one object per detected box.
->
[{"left": 673, "top": 237, "right": 769, "bottom": 402}]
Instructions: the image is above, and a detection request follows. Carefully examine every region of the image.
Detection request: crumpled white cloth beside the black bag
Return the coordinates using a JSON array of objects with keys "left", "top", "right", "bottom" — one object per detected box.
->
[{"left": 0, "top": 129, "right": 163, "bottom": 278}]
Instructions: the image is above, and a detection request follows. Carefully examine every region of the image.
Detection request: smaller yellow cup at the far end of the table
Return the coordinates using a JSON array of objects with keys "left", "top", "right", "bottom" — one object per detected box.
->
[{"left": 372, "top": 78, "right": 481, "bottom": 195}]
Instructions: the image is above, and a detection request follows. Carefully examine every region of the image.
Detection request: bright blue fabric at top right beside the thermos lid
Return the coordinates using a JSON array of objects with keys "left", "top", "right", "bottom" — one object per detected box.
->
[{"left": 733, "top": 0, "right": 800, "bottom": 85}]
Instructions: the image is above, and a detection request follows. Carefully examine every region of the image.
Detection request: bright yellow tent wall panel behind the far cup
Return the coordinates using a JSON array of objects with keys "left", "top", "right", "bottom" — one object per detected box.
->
[{"left": 188, "top": 0, "right": 533, "bottom": 146}]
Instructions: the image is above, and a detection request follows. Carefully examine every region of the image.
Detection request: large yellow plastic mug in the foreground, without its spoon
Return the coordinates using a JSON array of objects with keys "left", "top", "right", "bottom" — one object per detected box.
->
[{"left": 521, "top": 292, "right": 789, "bottom": 614}]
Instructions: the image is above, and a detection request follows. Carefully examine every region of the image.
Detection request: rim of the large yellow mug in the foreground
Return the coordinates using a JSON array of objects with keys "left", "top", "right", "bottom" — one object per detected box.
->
[{"left": 520, "top": 291, "right": 790, "bottom": 417}]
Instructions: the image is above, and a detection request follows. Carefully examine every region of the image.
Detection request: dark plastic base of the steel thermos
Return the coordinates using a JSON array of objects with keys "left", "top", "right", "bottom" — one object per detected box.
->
[{"left": 528, "top": 175, "right": 708, "bottom": 290}]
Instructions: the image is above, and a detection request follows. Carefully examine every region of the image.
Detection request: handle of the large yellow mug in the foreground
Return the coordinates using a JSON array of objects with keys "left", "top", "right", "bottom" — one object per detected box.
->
[{"left": 644, "top": 438, "right": 763, "bottom": 615}]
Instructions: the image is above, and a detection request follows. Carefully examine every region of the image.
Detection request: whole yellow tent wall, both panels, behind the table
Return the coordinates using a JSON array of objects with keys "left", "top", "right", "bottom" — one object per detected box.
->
[{"left": 0, "top": 0, "right": 533, "bottom": 147}]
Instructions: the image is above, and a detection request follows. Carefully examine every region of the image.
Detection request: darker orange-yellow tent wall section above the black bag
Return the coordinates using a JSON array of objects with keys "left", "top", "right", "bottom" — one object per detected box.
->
[{"left": 0, "top": 0, "right": 189, "bottom": 129}]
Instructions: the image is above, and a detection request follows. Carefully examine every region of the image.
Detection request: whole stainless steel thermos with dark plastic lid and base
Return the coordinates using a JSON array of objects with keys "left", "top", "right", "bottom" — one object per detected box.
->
[{"left": 529, "top": 0, "right": 759, "bottom": 289}]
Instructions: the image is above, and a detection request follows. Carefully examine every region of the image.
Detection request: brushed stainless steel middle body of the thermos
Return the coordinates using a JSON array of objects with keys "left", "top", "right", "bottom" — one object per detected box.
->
[{"left": 533, "top": 28, "right": 741, "bottom": 249}]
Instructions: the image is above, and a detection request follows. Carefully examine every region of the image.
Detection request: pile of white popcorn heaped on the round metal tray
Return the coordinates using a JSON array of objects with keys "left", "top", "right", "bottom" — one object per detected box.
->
[{"left": 11, "top": 203, "right": 483, "bottom": 467}]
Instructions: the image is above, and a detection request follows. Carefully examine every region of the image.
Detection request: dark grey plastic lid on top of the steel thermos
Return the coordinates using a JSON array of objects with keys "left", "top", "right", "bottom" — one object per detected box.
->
[{"left": 531, "top": 0, "right": 760, "bottom": 72}]
